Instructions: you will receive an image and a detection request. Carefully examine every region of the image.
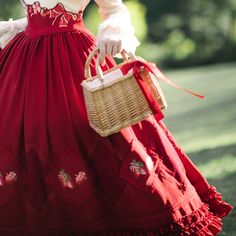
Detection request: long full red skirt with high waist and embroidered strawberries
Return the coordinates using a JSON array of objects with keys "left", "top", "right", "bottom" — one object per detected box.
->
[{"left": 0, "top": 1, "right": 232, "bottom": 236}]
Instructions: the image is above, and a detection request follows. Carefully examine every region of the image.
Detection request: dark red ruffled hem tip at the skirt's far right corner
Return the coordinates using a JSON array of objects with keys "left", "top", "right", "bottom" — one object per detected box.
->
[{"left": 200, "top": 185, "right": 233, "bottom": 218}]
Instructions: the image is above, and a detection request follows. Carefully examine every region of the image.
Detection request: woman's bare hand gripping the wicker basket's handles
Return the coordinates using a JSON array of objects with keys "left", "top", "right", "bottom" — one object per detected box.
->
[{"left": 97, "top": 34, "right": 122, "bottom": 65}]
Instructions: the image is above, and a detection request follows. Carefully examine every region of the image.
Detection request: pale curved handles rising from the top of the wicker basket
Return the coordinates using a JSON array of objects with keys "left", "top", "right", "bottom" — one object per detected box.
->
[{"left": 84, "top": 47, "right": 137, "bottom": 81}]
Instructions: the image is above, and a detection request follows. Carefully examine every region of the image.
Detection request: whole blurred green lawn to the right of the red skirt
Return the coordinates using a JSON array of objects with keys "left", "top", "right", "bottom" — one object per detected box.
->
[{"left": 160, "top": 63, "right": 236, "bottom": 236}]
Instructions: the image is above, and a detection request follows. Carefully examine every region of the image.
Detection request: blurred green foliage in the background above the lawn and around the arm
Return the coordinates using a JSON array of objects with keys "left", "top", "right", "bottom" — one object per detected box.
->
[{"left": 0, "top": 0, "right": 236, "bottom": 67}]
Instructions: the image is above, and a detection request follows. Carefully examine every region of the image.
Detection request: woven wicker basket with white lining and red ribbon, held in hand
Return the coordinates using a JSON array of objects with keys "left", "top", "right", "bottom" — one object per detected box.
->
[{"left": 81, "top": 48, "right": 167, "bottom": 137}]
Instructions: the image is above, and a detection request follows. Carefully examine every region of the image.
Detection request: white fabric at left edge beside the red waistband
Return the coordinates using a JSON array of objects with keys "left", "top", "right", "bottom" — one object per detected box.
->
[{"left": 0, "top": 17, "right": 28, "bottom": 49}]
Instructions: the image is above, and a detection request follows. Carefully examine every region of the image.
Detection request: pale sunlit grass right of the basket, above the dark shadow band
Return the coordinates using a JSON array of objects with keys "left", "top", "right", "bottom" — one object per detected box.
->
[{"left": 160, "top": 63, "right": 236, "bottom": 152}]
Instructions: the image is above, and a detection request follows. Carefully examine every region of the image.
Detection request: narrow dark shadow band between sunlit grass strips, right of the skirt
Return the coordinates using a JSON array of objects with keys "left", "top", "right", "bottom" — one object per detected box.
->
[{"left": 186, "top": 144, "right": 236, "bottom": 165}]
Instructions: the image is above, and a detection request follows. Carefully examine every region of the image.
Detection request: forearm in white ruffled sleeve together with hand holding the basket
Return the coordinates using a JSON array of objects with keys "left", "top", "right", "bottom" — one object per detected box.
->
[{"left": 95, "top": 0, "right": 140, "bottom": 64}]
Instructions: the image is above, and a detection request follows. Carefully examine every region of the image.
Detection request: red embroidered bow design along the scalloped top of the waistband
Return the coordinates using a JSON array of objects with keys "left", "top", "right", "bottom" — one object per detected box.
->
[{"left": 28, "top": 1, "right": 83, "bottom": 27}]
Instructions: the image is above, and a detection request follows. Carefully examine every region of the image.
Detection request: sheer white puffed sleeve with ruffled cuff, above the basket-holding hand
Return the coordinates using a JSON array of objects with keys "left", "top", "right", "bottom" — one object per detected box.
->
[{"left": 95, "top": 0, "right": 140, "bottom": 57}]
